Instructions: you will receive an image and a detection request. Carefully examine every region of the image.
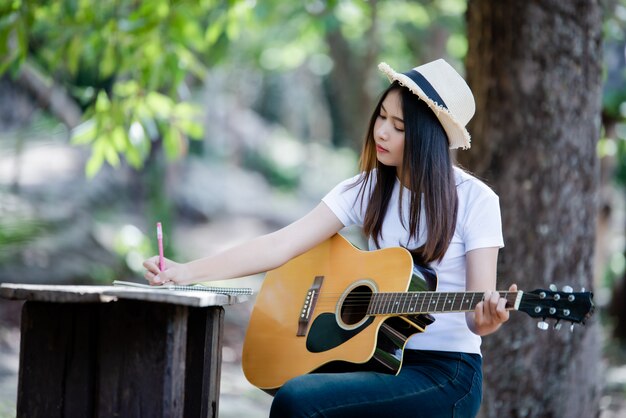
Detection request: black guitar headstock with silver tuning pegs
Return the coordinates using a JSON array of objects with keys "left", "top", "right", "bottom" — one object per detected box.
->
[{"left": 518, "top": 285, "right": 594, "bottom": 329}]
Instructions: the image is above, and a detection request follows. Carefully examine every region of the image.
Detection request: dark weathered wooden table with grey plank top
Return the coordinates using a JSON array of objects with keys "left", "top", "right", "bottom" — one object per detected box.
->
[{"left": 0, "top": 283, "right": 246, "bottom": 418}]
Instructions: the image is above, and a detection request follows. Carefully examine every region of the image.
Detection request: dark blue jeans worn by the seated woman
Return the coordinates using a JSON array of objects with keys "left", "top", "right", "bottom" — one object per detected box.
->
[{"left": 270, "top": 350, "right": 482, "bottom": 418}]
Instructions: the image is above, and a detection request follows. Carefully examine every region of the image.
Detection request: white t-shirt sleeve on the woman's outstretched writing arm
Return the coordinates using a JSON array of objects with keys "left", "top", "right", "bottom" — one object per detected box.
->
[{"left": 322, "top": 176, "right": 364, "bottom": 226}]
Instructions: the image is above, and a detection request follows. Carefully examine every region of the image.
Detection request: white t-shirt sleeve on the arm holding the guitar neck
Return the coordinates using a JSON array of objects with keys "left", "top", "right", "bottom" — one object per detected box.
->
[{"left": 463, "top": 189, "right": 504, "bottom": 252}]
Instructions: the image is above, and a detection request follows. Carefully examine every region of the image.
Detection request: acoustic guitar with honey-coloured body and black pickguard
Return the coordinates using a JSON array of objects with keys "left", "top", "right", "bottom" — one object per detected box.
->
[{"left": 242, "top": 234, "right": 594, "bottom": 393}]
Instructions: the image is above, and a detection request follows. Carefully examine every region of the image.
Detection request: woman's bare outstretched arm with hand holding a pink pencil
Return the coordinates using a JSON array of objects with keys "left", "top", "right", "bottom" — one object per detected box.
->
[{"left": 143, "top": 202, "right": 343, "bottom": 284}]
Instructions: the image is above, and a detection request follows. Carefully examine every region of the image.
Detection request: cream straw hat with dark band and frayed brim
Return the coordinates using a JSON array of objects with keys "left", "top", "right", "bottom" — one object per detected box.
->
[{"left": 378, "top": 59, "right": 476, "bottom": 149}]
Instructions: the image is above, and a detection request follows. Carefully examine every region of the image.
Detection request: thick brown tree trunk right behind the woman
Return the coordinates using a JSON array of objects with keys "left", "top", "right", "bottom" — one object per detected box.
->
[{"left": 458, "top": 0, "right": 601, "bottom": 418}]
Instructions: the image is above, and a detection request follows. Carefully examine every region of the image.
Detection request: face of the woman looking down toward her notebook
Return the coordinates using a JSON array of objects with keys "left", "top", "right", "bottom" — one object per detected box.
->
[{"left": 373, "top": 89, "right": 404, "bottom": 171}]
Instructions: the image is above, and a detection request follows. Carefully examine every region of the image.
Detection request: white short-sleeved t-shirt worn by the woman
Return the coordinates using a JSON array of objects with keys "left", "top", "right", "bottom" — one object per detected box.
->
[{"left": 322, "top": 167, "right": 504, "bottom": 354}]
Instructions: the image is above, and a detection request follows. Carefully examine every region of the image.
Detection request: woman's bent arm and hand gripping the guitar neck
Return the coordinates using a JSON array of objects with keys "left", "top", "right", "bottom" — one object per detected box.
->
[{"left": 465, "top": 247, "right": 517, "bottom": 335}]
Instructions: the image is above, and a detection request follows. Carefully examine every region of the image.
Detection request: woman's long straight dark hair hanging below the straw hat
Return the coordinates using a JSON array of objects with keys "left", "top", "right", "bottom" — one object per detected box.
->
[{"left": 354, "top": 82, "right": 458, "bottom": 263}]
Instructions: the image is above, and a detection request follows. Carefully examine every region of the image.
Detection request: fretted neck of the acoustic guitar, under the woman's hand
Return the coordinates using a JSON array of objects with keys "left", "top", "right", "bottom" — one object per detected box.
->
[{"left": 367, "top": 291, "right": 523, "bottom": 315}]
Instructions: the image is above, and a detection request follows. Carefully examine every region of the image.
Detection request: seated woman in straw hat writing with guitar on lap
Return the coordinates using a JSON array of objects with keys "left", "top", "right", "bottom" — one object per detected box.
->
[{"left": 144, "top": 60, "right": 516, "bottom": 417}]
